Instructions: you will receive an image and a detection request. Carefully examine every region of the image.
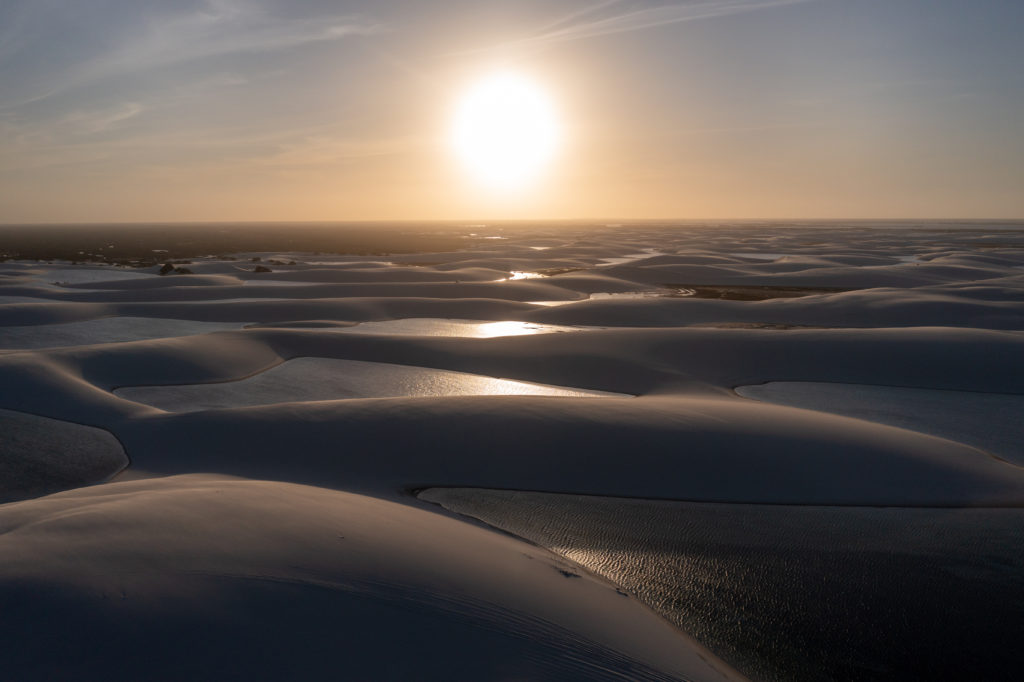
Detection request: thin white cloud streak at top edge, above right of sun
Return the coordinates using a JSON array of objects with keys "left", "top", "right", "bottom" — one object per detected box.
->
[{"left": 460, "top": 0, "right": 813, "bottom": 52}]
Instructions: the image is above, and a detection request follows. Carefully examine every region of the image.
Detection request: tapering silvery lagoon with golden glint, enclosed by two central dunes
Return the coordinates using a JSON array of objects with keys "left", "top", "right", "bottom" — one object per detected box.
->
[{"left": 115, "top": 357, "right": 622, "bottom": 412}]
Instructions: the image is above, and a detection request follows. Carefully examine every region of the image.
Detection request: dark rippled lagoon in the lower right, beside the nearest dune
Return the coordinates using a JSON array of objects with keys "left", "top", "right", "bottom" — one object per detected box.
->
[{"left": 421, "top": 485, "right": 1024, "bottom": 682}]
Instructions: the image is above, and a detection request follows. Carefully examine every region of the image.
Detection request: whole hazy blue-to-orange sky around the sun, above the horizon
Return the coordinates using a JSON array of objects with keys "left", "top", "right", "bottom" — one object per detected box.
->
[{"left": 0, "top": 0, "right": 1024, "bottom": 223}]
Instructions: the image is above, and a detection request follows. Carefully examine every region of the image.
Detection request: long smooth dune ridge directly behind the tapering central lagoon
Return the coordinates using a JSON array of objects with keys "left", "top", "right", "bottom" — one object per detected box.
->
[{"left": 0, "top": 328, "right": 1024, "bottom": 413}]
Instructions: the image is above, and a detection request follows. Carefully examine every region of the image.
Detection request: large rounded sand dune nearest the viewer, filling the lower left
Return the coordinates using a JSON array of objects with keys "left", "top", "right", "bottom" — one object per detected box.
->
[{"left": 0, "top": 475, "right": 742, "bottom": 681}]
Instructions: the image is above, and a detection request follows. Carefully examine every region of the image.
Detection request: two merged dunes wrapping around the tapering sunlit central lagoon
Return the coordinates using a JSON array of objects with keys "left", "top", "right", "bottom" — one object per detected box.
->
[{"left": 0, "top": 329, "right": 1024, "bottom": 506}]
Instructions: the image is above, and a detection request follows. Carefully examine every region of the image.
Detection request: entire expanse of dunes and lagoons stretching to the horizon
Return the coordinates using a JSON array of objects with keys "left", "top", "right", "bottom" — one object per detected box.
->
[{"left": 0, "top": 223, "right": 1024, "bottom": 681}]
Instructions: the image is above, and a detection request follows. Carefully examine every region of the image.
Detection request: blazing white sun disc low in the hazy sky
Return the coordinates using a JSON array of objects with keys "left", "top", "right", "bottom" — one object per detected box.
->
[{"left": 451, "top": 72, "right": 561, "bottom": 189}]
